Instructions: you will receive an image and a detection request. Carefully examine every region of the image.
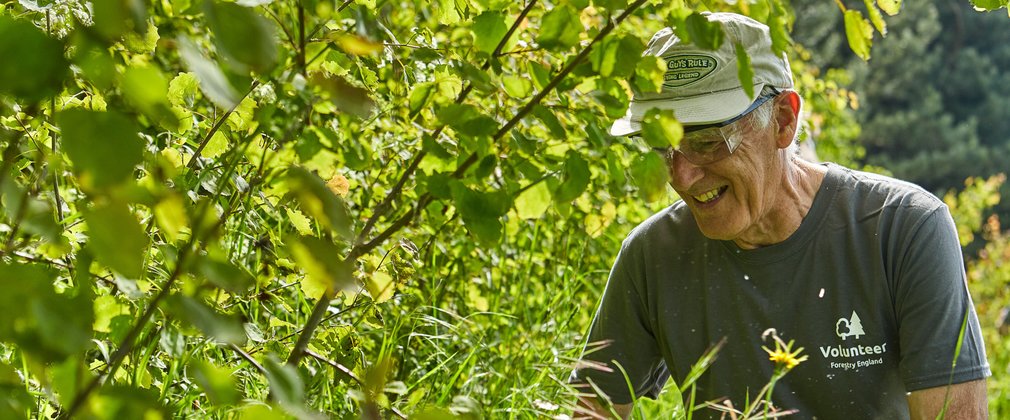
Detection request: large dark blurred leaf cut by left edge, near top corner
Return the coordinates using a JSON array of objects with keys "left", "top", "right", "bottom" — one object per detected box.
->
[{"left": 0, "top": 16, "right": 70, "bottom": 102}]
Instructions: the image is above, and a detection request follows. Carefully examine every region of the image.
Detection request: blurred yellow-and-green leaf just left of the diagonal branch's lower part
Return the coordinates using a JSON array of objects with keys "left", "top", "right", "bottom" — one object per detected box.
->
[{"left": 286, "top": 236, "right": 354, "bottom": 299}]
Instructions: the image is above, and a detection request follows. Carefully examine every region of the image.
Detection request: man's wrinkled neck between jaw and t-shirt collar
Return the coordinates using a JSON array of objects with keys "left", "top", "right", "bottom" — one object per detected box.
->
[{"left": 734, "top": 156, "right": 827, "bottom": 249}]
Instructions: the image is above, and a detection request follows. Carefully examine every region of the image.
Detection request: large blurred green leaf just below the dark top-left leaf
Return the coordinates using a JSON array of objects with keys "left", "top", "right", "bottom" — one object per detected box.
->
[{"left": 57, "top": 108, "right": 143, "bottom": 189}]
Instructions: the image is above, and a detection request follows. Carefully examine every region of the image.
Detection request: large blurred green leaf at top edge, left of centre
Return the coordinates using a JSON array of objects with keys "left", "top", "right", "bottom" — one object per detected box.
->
[{"left": 204, "top": 0, "right": 277, "bottom": 74}]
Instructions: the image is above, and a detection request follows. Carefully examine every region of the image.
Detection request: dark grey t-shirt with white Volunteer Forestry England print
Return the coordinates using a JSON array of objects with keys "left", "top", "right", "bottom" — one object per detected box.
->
[{"left": 572, "top": 164, "right": 990, "bottom": 419}]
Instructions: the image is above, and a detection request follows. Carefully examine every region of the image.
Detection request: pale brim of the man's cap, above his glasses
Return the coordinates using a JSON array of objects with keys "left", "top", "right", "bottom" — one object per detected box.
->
[{"left": 610, "top": 83, "right": 765, "bottom": 136}]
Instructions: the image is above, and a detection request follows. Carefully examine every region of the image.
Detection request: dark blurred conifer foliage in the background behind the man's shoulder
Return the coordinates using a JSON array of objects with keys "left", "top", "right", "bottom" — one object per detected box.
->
[{"left": 795, "top": 0, "right": 1010, "bottom": 223}]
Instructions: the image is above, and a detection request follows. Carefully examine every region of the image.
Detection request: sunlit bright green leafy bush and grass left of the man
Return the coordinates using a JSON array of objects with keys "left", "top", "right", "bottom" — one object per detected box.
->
[{"left": 0, "top": 0, "right": 993, "bottom": 418}]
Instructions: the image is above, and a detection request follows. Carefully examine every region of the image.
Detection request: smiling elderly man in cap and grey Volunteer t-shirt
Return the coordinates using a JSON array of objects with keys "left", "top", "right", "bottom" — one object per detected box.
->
[{"left": 572, "top": 13, "right": 990, "bottom": 419}]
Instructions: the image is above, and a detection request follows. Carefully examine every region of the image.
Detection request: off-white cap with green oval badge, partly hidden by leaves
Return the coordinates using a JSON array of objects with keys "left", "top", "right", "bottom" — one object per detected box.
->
[{"left": 610, "top": 13, "right": 793, "bottom": 135}]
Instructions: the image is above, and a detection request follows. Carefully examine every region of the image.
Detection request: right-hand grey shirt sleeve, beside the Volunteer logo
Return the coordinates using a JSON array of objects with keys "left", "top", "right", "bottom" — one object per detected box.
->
[{"left": 895, "top": 205, "right": 990, "bottom": 391}]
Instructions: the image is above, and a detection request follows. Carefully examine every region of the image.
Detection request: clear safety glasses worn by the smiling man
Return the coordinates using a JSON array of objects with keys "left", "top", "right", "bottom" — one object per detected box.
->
[{"left": 653, "top": 92, "right": 778, "bottom": 166}]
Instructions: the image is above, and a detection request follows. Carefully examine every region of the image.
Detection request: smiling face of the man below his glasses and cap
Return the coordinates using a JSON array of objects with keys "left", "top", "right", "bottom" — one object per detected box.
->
[{"left": 667, "top": 110, "right": 788, "bottom": 243}]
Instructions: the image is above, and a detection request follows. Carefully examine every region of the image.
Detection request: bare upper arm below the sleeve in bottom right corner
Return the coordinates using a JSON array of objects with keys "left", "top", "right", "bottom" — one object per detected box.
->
[{"left": 908, "top": 380, "right": 989, "bottom": 420}]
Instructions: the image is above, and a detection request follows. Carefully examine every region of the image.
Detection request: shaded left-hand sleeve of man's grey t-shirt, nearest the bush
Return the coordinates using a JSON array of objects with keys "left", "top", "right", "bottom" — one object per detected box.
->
[{"left": 570, "top": 242, "right": 670, "bottom": 404}]
